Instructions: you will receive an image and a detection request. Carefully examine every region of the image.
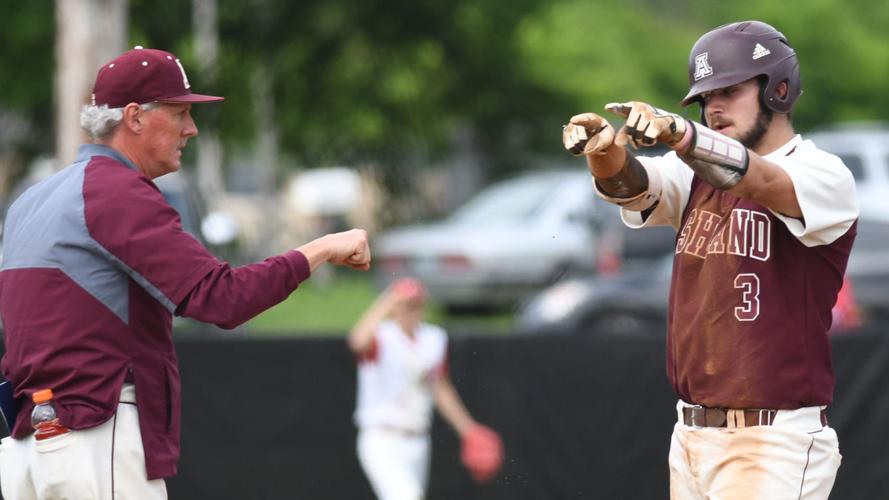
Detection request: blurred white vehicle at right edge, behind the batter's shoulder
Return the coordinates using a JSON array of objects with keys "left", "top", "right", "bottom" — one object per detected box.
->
[{"left": 804, "top": 123, "right": 889, "bottom": 222}]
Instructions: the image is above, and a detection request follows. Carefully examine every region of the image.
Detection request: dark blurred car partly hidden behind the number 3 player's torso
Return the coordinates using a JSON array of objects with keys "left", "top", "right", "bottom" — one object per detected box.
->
[{"left": 516, "top": 219, "right": 889, "bottom": 337}]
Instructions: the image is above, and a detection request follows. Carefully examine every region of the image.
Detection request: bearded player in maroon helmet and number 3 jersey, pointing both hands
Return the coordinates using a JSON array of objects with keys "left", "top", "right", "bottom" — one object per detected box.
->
[{"left": 563, "top": 21, "right": 858, "bottom": 499}]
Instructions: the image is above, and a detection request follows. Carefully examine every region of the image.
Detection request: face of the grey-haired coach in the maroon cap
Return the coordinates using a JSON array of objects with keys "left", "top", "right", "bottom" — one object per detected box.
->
[{"left": 142, "top": 103, "right": 198, "bottom": 179}]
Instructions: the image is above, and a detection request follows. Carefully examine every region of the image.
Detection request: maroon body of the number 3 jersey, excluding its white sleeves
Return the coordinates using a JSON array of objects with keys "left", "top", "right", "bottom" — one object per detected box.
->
[{"left": 667, "top": 177, "right": 855, "bottom": 408}]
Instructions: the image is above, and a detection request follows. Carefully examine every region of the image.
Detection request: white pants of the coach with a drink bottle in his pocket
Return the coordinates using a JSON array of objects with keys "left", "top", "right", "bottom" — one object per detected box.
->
[{"left": 0, "top": 384, "right": 167, "bottom": 500}]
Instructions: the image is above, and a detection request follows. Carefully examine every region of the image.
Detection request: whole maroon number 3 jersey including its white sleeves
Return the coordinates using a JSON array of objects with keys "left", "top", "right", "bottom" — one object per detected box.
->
[{"left": 600, "top": 136, "right": 858, "bottom": 409}]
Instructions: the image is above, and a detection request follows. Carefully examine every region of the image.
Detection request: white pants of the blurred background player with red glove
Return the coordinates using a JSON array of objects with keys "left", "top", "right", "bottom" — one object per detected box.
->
[{"left": 358, "top": 427, "right": 431, "bottom": 500}]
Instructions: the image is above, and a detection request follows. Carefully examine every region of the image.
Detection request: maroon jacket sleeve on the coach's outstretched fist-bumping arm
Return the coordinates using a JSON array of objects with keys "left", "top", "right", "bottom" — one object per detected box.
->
[{"left": 84, "top": 165, "right": 310, "bottom": 328}]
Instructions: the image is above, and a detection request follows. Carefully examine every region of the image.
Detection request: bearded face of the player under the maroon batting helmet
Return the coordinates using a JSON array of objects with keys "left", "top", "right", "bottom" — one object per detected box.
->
[{"left": 701, "top": 78, "right": 772, "bottom": 148}]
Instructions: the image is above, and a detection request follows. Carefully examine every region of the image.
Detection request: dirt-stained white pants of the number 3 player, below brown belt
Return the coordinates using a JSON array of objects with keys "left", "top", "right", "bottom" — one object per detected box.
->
[{"left": 670, "top": 401, "right": 842, "bottom": 500}]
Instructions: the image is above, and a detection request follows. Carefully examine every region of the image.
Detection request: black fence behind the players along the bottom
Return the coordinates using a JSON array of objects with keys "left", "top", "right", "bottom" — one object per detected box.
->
[{"left": 160, "top": 332, "right": 889, "bottom": 500}]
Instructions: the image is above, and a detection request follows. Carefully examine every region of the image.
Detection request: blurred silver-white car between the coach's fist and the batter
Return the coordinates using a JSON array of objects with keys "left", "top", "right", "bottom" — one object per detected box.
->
[{"left": 373, "top": 168, "right": 672, "bottom": 310}]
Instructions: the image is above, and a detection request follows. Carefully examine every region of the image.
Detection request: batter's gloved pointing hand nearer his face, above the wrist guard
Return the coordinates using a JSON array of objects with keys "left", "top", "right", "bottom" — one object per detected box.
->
[{"left": 605, "top": 101, "right": 686, "bottom": 147}]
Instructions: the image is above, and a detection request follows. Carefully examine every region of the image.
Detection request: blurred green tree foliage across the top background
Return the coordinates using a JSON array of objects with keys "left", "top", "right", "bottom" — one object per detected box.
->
[{"left": 0, "top": 0, "right": 889, "bottom": 183}]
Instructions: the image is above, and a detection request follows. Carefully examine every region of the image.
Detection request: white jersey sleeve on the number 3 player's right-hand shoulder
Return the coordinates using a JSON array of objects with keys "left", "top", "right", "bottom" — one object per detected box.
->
[{"left": 768, "top": 147, "right": 858, "bottom": 247}]
